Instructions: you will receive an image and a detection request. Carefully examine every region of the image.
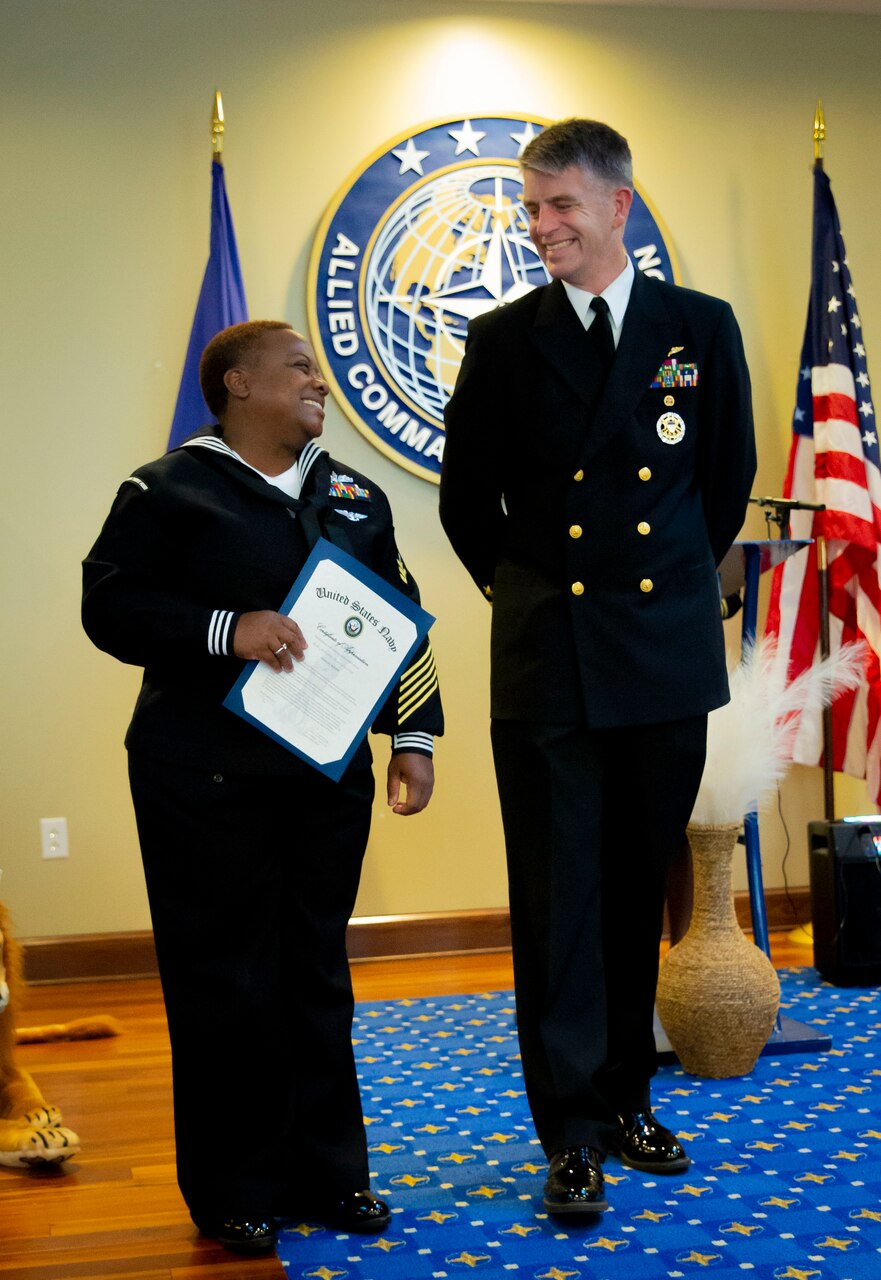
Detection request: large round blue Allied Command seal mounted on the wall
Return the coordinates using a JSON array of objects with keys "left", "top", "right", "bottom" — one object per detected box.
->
[{"left": 307, "top": 115, "right": 679, "bottom": 483}]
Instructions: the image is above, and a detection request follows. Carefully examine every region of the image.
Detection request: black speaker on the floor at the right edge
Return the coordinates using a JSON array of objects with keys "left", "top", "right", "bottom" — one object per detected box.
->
[{"left": 808, "top": 815, "right": 881, "bottom": 987}]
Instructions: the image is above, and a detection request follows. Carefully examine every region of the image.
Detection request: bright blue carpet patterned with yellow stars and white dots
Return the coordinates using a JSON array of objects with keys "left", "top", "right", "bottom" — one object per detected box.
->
[{"left": 278, "top": 969, "right": 881, "bottom": 1280}]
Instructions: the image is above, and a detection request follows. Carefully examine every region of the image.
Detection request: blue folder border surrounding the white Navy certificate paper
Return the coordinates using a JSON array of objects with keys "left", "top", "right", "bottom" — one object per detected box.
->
[{"left": 223, "top": 538, "right": 434, "bottom": 782}]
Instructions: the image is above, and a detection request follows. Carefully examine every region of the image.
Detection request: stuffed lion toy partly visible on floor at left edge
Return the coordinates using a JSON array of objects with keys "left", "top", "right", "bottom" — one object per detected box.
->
[{"left": 0, "top": 906, "right": 83, "bottom": 1167}]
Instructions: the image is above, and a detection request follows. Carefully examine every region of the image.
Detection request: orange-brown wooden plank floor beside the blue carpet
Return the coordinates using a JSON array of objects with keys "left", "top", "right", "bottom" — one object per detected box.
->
[{"left": 0, "top": 934, "right": 812, "bottom": 1280}]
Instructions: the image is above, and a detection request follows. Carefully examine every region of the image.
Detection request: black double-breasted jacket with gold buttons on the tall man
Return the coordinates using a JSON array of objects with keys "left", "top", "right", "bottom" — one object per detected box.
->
[{"left": 441, "top": 271, "right": 756, "bottom": 727}]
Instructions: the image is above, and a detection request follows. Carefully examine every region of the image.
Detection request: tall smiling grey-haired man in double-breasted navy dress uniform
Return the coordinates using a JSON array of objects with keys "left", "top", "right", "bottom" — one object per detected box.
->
[{"left": 441, "top": 119, "right": 756, "bottom": 1213}]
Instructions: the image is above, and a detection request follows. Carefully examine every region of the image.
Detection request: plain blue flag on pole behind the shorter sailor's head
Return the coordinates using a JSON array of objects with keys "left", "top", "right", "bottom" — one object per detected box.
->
[{"left": 168, "top": 160, "right": 247, "bottom": 449}]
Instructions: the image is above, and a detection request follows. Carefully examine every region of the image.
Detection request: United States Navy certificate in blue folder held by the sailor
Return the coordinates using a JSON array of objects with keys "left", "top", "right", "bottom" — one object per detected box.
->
[{"left": 223, "top": 538, "right": 434, "bottom": 781}]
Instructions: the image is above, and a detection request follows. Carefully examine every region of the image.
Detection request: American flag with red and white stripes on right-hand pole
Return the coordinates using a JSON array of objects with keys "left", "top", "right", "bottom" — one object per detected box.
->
[{"left": 766, "top": 164, "right": 881, "bottom": 804}]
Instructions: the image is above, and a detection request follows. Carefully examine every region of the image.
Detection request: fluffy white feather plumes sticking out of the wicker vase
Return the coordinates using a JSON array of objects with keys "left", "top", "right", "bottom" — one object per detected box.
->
[{"left": 691, "top": 637, "right": 864, "bottom": 824}]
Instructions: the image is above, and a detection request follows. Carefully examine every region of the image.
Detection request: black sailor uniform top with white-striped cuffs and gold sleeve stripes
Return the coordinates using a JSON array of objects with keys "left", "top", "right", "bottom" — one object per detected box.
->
[{"left": 82, "top": 439, "right": 443, "bottom": 773}]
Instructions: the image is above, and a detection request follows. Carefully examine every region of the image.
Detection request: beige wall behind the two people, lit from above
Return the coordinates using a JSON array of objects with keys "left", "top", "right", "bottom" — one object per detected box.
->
[{"left": 0, "top": 0, "right": 881, "bottom": 936}]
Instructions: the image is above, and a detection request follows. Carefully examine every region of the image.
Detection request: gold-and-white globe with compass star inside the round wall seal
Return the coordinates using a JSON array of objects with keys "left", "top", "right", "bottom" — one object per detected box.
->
[{"left": 362, "top": 163, "right": 548, "bottom": 425}]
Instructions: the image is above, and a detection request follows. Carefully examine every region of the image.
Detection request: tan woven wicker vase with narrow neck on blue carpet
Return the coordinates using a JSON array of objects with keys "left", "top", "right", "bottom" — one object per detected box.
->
[{"left": 657, "top": 823, "right": 780, "bottom": 1079}]
